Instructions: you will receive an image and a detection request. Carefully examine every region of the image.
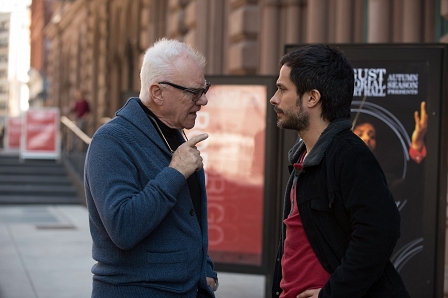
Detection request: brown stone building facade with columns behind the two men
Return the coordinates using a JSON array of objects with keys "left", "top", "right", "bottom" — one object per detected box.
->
[{"left": 45, "top": 0, "right": 448, "bottom": 132}]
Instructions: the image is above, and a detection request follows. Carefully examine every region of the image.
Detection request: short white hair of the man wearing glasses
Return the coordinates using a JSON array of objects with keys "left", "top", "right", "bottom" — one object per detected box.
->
[{"left": 139, "top": 38, "right": 206, "bottom": 103}]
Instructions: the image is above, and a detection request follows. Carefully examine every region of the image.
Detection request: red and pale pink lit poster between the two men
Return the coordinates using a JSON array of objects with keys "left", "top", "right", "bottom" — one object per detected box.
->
[{"left": 186, "top": 76, "right": 276, "bottom": 273}]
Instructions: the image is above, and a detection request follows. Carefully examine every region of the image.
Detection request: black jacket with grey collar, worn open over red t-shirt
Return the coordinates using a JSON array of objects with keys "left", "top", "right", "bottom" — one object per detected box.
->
[{"left": 272, "top": 119, "right": 409, "bottom": 298}]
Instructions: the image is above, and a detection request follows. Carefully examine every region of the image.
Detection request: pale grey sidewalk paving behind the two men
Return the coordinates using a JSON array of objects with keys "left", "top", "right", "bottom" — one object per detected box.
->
[{"left": 0, "top": 205, "right": 265, "bottom": 298}]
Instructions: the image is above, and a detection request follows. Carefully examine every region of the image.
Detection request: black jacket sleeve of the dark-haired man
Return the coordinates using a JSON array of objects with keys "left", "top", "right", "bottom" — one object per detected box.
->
[{"left": 319, "top": 146, "right": 400, "bottom": 298}]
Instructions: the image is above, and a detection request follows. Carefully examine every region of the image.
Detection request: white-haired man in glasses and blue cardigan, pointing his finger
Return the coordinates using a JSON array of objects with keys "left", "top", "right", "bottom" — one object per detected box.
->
[{"left": 84, "top": 39, "right": 218, "bottom": 298}]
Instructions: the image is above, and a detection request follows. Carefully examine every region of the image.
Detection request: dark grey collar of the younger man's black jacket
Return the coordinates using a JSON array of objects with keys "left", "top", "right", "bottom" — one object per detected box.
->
[{"left": 288, "top": 118, "right": 352, "bottom": 167}]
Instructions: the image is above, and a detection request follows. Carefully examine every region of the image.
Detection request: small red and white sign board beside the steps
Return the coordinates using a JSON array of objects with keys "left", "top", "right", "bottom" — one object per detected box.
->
[{"left": 20, "top": 108, "right": 61, "bottom": 159}]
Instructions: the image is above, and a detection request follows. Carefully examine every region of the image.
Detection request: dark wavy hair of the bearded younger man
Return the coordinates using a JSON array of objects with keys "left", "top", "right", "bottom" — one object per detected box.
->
[{"left": 280, "top": 44, "right": 354, "bottom": 121}]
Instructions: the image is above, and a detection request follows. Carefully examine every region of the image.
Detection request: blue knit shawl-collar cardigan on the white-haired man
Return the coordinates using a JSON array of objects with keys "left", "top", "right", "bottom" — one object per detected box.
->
[{"left": 84, "top": 98, "right": 216, "bottom": 298}]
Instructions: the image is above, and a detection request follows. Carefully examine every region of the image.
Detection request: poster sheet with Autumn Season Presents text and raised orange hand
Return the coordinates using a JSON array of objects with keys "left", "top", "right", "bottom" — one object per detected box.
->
[{"left": 351, "top": 61, "right": 428, "bottom": 293}]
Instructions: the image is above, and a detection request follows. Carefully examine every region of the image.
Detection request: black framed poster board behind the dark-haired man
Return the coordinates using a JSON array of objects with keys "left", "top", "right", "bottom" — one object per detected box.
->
[{"left": 287, "top": 44, "right": 447, "bottom": 297}]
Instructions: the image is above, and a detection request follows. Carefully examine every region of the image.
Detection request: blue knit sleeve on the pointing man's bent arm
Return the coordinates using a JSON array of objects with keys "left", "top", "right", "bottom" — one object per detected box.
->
[{"left": 85, "top": 132, "right": 186, "bottom": 250}]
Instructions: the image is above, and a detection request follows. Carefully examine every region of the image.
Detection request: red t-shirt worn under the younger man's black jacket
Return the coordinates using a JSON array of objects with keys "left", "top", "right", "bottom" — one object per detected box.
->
[{"left": 280, "top": 155, "right": 330, "bottom": 298}]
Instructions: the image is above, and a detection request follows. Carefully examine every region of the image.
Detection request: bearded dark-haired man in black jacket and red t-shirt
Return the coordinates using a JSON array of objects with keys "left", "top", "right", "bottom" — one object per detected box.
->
[{"left": 270, "top": 45, "right": 409, "bottom": 298}]
